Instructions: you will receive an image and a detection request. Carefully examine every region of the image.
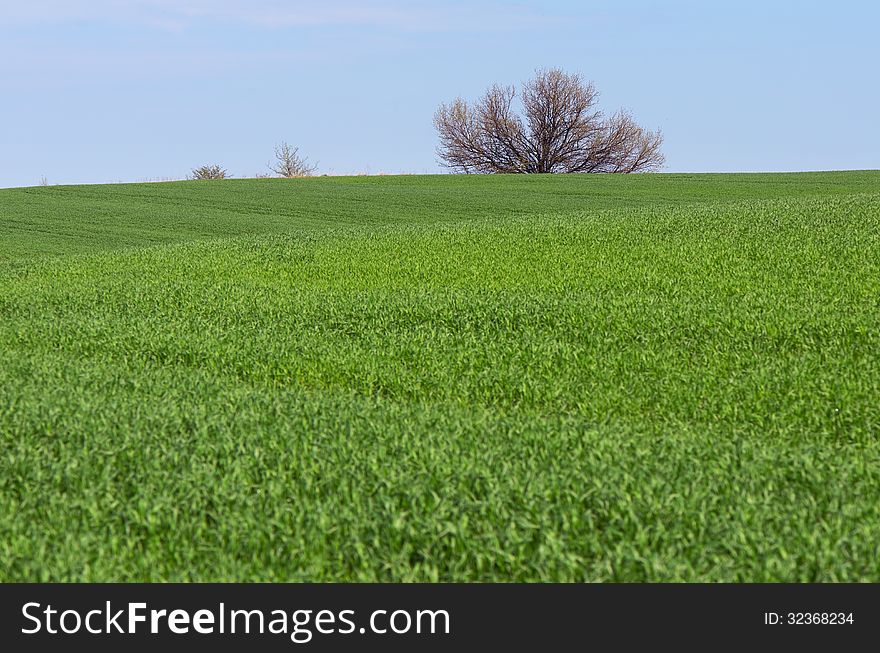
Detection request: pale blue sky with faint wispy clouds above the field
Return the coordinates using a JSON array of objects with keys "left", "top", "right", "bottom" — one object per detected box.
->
[{"left": 0, "top": 0, "right": 880, "bottom": 186}]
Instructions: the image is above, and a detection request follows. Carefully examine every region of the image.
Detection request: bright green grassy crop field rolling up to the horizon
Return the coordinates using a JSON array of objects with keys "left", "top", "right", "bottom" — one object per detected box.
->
[{"left": 0, "top": 172, "right": 880, "bottom": 581}]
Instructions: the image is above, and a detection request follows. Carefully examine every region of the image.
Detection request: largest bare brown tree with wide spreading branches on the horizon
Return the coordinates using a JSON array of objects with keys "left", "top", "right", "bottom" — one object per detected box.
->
[{"left": 434, "top": 69, "right": 665, "bottom": 173}]
